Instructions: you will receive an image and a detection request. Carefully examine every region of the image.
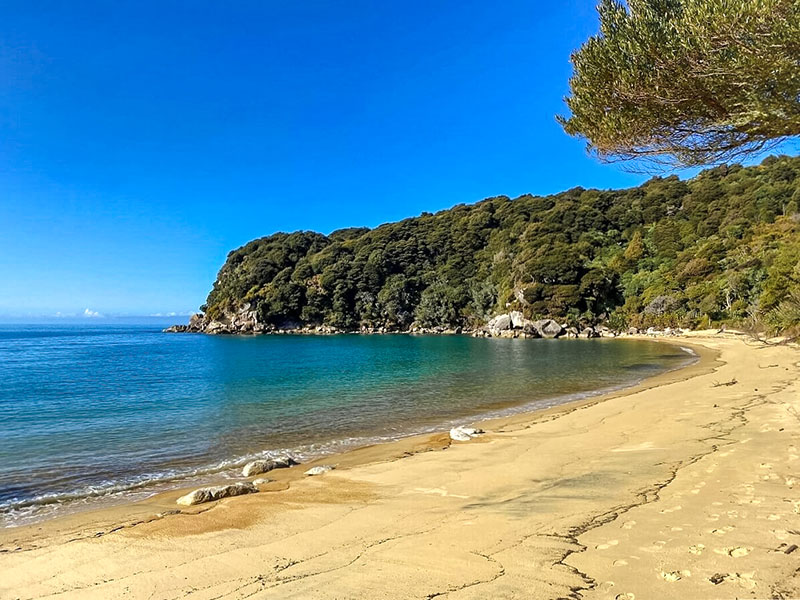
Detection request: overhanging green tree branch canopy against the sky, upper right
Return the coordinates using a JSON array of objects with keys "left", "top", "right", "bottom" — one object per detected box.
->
[{"left": 558, "top": 0, "right": 800, "bottom": 166}]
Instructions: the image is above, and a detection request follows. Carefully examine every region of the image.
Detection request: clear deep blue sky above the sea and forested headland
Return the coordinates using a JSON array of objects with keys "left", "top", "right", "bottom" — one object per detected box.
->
[{"left": 0, "top": 0, "right": 788, "bottom": 316}]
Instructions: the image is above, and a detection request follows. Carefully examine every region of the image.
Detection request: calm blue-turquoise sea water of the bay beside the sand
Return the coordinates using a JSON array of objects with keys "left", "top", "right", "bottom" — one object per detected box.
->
[{"left": 0, "top": 324, "right": 689, "bottom": 526}]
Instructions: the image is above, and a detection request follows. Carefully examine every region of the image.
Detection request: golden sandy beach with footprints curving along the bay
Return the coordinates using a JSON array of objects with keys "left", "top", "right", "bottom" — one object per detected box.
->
[{"left": 0, "top": 334, "right": 800, "bottom": 600}]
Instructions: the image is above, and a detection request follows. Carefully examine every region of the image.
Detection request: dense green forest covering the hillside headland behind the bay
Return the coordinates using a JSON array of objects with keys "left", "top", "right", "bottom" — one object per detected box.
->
[{"left": 202, "top": 156, "right": 800, "bottom": 331}]
